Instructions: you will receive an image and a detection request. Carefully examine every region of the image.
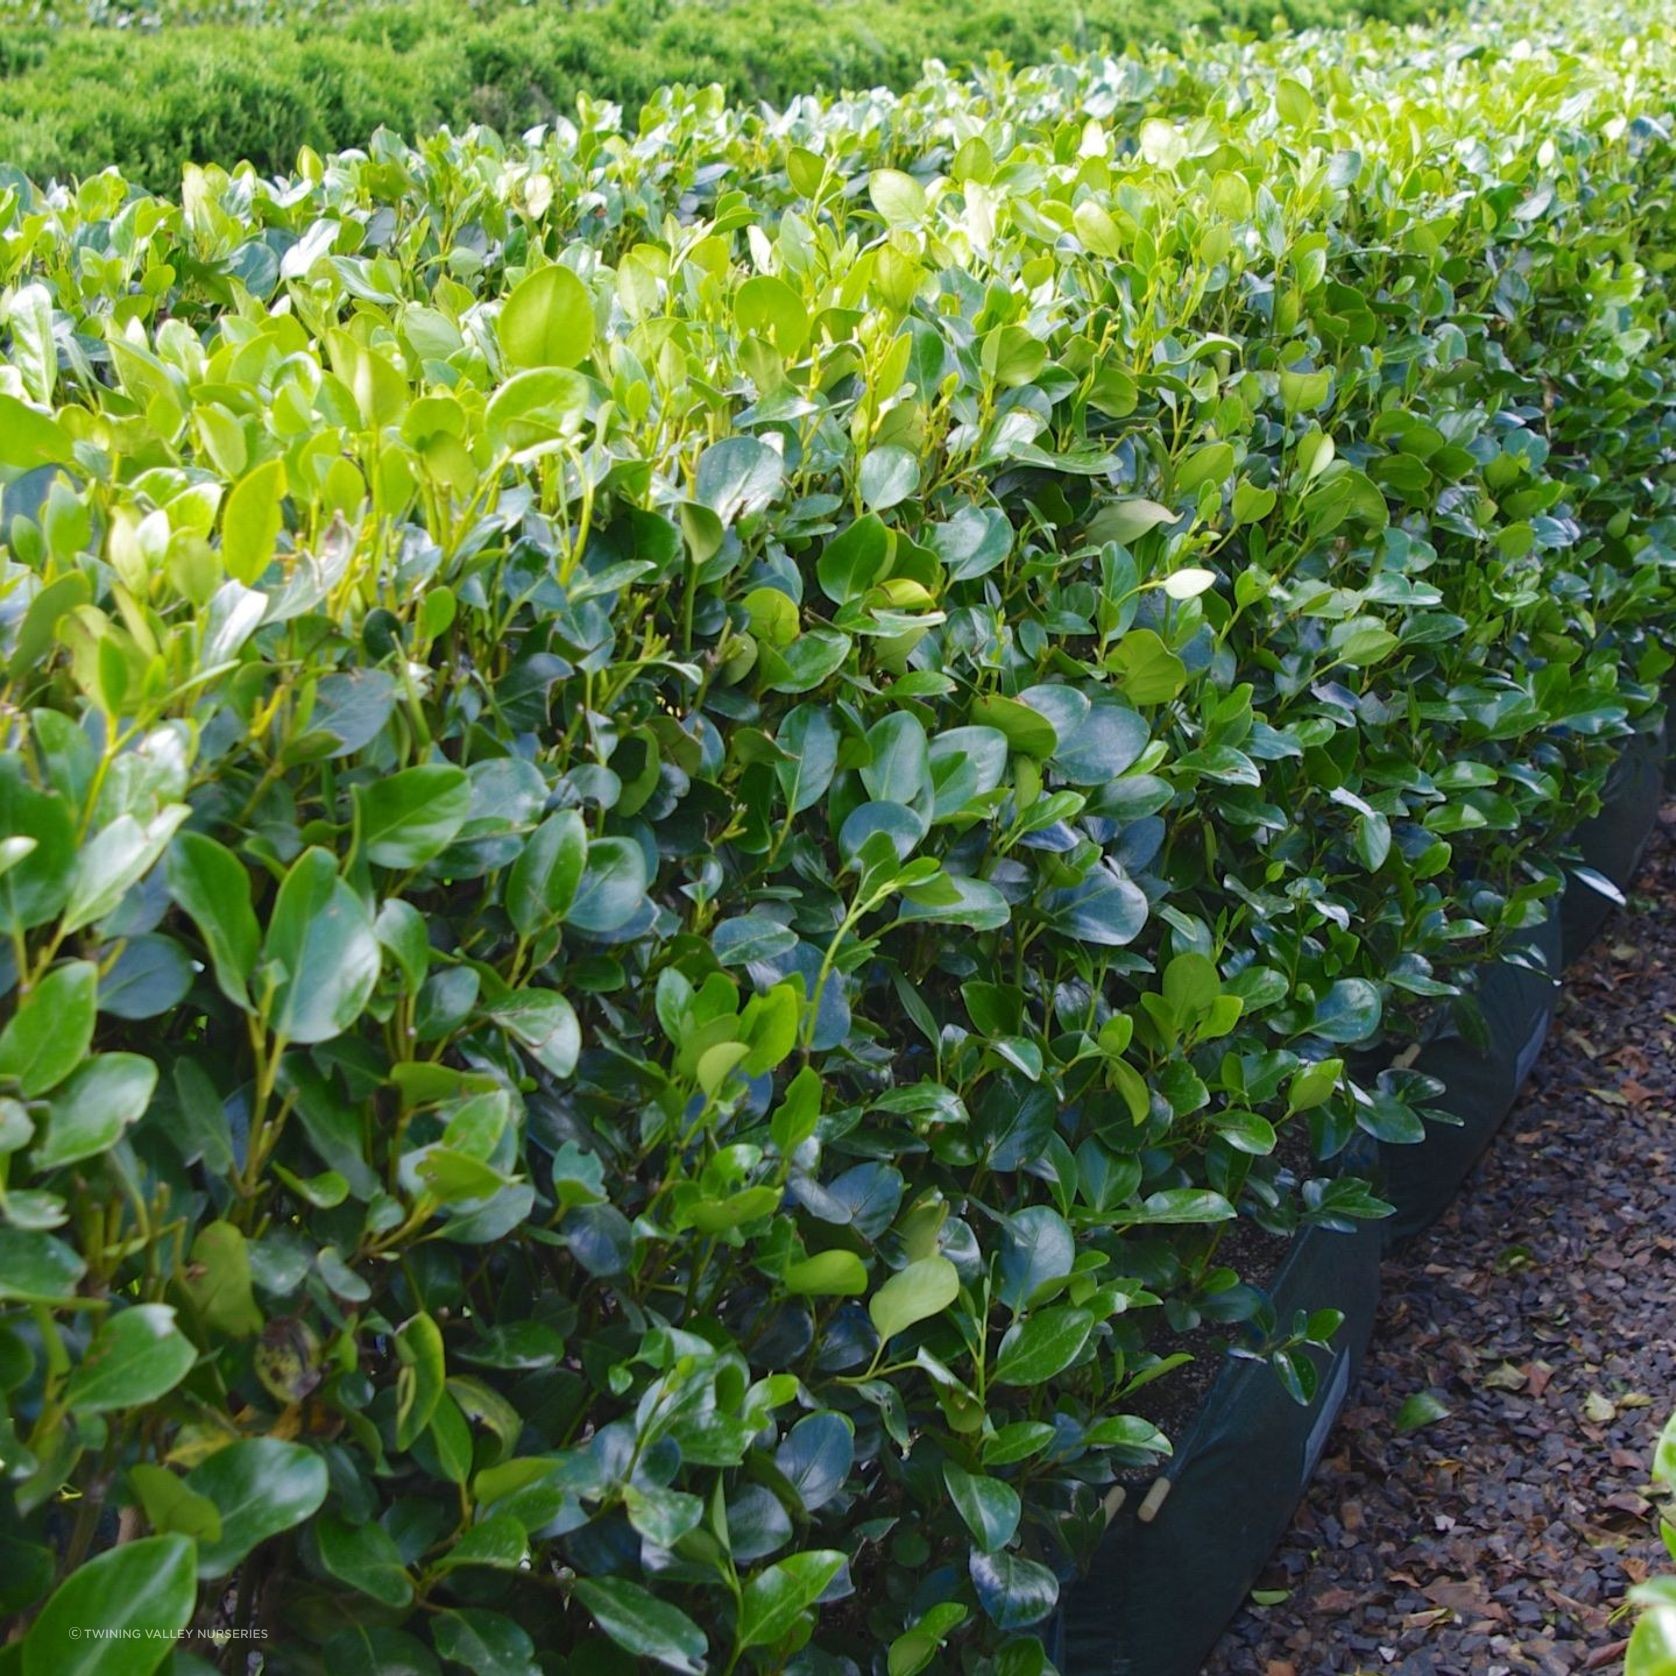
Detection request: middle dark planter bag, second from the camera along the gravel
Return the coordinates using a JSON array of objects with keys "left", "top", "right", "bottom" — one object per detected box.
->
[{"left": 1379, "top": 913, "right": 1562, "bottom": 1244}]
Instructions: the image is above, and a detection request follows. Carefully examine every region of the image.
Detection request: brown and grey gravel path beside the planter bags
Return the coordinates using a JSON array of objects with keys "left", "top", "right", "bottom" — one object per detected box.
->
[{"left": 1205, "top": 804, "right": 1676, "bottom": 1676}]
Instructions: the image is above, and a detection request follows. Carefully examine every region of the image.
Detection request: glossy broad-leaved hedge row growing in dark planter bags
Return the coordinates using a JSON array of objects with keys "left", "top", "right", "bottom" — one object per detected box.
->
[{"left": 0, "top": 5, "right": 1676, "bottom": 1676}]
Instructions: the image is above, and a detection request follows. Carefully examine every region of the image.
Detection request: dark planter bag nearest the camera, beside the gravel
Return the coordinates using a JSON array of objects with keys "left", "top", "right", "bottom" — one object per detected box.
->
[{"left": 1054, "top": 1223, "right": 1379, "bottom": 1676}]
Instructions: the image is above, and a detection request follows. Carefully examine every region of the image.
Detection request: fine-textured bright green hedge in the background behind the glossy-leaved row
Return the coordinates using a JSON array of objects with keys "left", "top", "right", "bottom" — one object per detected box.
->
[{"left": 0, "top": 0, "right": 1441, "bottom": 189}]
